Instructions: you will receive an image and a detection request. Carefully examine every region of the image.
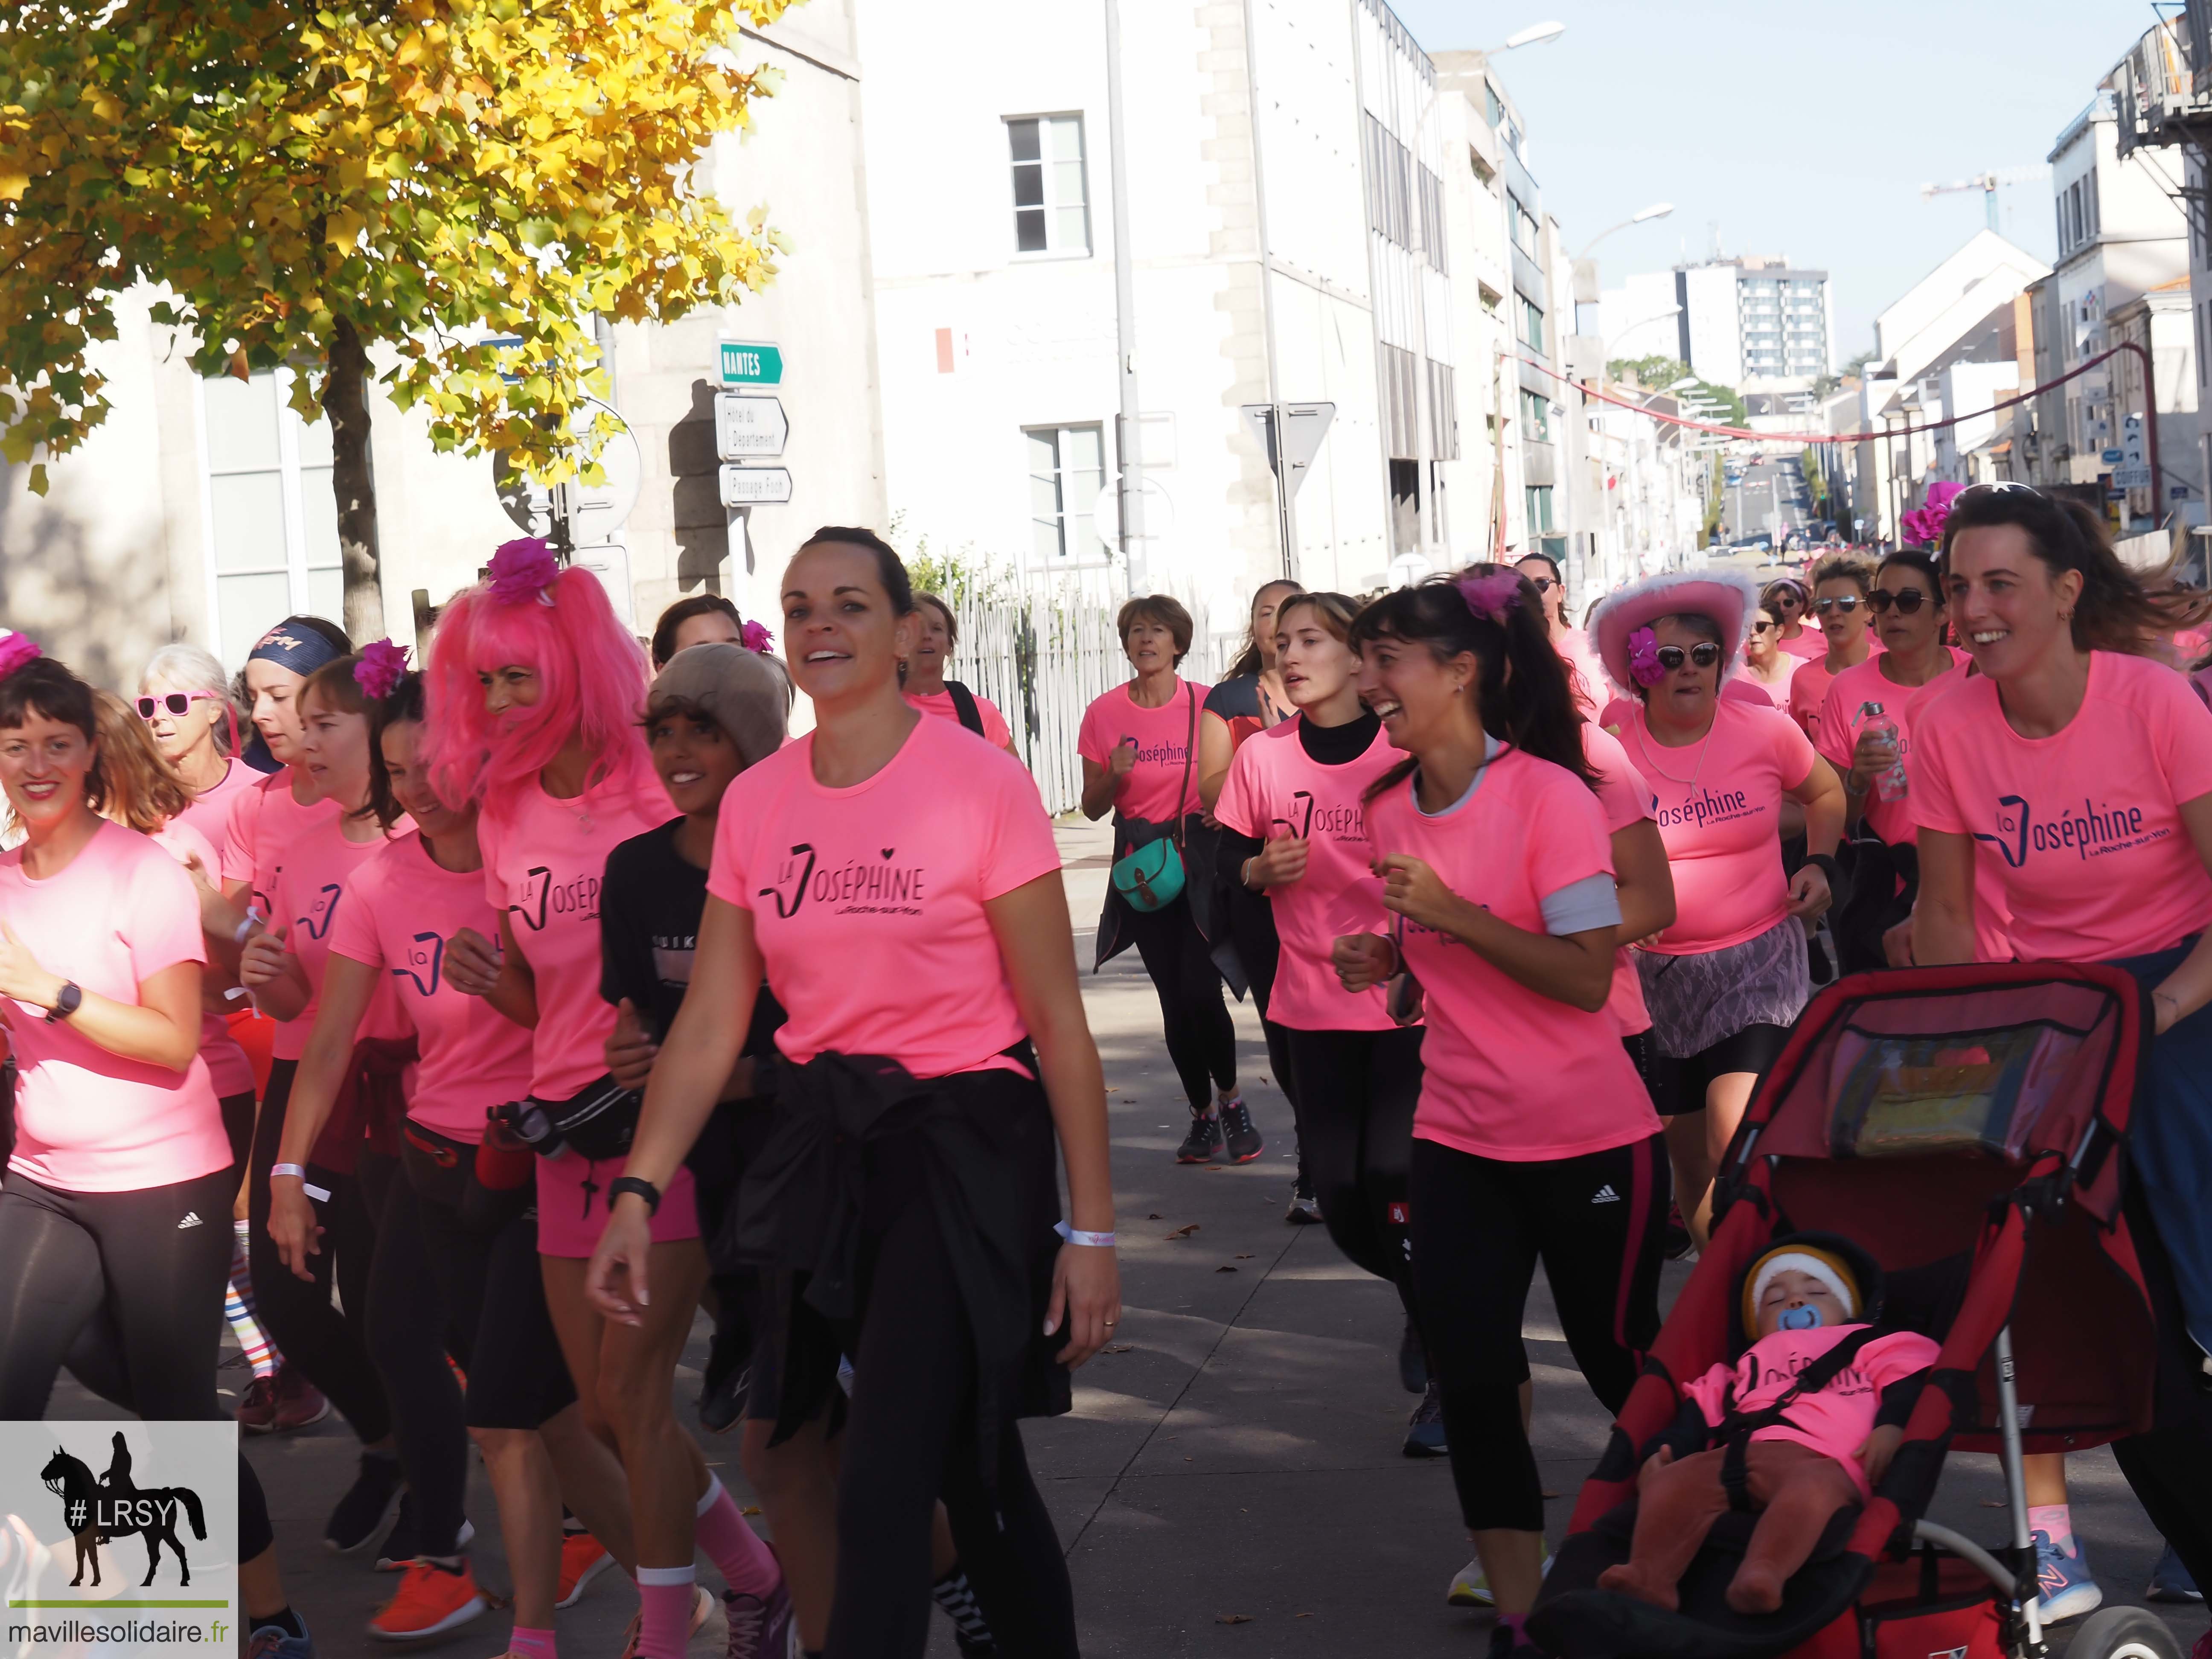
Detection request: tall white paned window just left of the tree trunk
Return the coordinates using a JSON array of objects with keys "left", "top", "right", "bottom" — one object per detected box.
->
[{"left": 199, "top": 374, "right": 345, "bottom": 668}]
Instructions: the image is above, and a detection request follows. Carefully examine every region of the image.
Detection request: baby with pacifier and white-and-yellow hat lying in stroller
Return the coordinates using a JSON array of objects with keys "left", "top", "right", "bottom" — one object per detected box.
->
[{"left": 1597, "top": 1232, "right": 1940, "bottom": 1615}]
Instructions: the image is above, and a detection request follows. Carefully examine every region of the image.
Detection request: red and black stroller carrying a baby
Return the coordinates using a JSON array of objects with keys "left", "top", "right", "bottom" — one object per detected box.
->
[{"left": 1528, "top": 962, "right": 2179, "bottom": 1659}]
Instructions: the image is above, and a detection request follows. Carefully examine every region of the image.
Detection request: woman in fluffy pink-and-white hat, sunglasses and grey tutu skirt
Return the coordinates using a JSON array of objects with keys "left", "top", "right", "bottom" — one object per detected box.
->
[{"left": 1592, "top": 570, "right": 1842, "bottom": 1243}]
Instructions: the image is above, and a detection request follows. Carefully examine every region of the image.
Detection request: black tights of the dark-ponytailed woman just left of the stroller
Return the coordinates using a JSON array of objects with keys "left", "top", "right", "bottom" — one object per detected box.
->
[{"left": 1409, "top": 1135, "right": 1668, "bottom": 1533}]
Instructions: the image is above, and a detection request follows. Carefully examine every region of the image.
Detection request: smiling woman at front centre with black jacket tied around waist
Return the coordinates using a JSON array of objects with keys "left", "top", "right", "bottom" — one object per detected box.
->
[{"left": 591, "top": 527, "right": 1119, "bottom": 1659}]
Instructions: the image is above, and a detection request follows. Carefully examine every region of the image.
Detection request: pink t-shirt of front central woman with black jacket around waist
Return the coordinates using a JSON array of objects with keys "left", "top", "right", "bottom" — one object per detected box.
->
[{"left": 706, "top": 719, "right": 1059, "bottom": 1077}]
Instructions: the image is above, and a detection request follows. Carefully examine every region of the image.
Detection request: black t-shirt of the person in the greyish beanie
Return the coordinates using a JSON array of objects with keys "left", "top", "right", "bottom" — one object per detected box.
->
[{"left": 600, "top": 818, "right": 783, "bottom": 1055}]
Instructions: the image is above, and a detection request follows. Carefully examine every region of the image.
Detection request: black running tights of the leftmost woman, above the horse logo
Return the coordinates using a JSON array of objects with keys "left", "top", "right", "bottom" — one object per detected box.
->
[{"left": 0, "top": 1166, "right": 237, "bottom": 1422}]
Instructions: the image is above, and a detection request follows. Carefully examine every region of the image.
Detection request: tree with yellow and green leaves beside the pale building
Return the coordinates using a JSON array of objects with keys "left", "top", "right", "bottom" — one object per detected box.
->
[{"left": 0, "top": 0, "right": 790, "bottom": 639}]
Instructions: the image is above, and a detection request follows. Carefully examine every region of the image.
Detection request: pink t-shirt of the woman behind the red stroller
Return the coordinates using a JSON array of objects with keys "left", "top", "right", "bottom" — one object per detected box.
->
[{"left": 1911, "top": 650, "right": 2212, "bottom": 962}]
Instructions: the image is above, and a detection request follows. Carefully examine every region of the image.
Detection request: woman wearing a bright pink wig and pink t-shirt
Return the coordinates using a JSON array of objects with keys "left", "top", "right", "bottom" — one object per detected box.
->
[{"left": 427, "top": 538, "right": 788, "bottom": 1659}]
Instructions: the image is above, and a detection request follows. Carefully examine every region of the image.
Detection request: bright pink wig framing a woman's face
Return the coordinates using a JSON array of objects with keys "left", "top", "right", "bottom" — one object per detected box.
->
[{"left": 422, "top": 566, "right": 661, "bottom": 821}]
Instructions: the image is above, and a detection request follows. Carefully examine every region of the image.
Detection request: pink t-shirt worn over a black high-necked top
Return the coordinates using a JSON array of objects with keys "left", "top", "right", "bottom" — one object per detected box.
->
[{"left": 1214, "top": 717, "right": 1405, "bottom": 1031}]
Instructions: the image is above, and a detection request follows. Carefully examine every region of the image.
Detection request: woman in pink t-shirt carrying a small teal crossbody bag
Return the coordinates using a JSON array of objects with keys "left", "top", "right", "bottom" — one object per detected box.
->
[{"left": 1075, "top": 593, "right": 1263, "bottom": 1164}]
